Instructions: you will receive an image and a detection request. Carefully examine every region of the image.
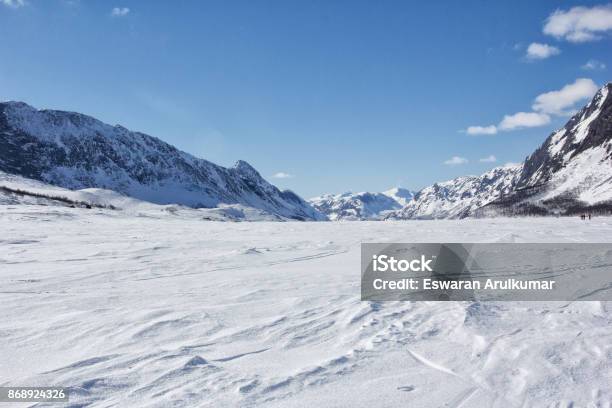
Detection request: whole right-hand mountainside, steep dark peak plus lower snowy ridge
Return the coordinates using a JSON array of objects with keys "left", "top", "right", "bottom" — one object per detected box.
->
[{"left": 385, "top": 84, "right": 612, "bottom": 220}]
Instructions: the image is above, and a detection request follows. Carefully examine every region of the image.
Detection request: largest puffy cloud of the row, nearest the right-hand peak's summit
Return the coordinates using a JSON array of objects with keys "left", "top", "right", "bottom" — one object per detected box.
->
[{"left": 532, "top": 78, "right": 597, "bottom": 115}]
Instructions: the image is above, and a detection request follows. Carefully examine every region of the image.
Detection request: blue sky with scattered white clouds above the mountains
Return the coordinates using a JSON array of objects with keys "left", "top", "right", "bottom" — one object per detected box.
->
[{"left": 0, "top": 0, "right": 612, "bottom": 197}]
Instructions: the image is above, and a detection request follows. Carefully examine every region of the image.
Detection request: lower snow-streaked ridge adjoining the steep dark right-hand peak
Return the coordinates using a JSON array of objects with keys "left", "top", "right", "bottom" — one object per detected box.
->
[{"left": 385, "top": 165, "right": 522, "bottom": 220}]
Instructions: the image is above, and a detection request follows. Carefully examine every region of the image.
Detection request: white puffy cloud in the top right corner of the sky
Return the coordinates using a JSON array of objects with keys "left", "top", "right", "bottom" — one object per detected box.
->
[{"left": 543, "top": 4, "right": 612, "bottom": 43}]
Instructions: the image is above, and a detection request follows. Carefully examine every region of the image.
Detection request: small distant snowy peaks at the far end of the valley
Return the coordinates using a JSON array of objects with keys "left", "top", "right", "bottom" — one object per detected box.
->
[{"left": 309, "top": 189, "right": 409, "bottom": 221}]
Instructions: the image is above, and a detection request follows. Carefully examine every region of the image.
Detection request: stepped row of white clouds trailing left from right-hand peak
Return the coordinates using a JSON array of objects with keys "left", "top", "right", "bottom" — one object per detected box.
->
[{"left": 465, "top": 78, "right": 597, "bottom": 135}]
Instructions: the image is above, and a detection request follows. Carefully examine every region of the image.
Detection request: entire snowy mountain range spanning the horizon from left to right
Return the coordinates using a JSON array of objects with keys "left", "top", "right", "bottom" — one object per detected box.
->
[{"left": 0, "top": 83, "right": 612, "bottom": 220}]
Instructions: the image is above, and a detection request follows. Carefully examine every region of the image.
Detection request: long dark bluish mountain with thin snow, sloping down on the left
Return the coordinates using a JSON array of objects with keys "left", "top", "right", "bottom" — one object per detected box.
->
[{"left": 0, "top": 102, "right": 325, "bottom": 220}]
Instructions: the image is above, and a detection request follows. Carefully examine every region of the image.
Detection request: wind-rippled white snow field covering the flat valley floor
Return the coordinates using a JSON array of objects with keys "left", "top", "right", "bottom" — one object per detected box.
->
[{"left": 0, "top": 205, "right": 612, "bottom": 407}]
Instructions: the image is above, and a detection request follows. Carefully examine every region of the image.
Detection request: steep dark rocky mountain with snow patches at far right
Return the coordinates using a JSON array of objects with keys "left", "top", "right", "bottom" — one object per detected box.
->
[{"left": 478, "top": 83, "right": 612, "bottom": 215}]
